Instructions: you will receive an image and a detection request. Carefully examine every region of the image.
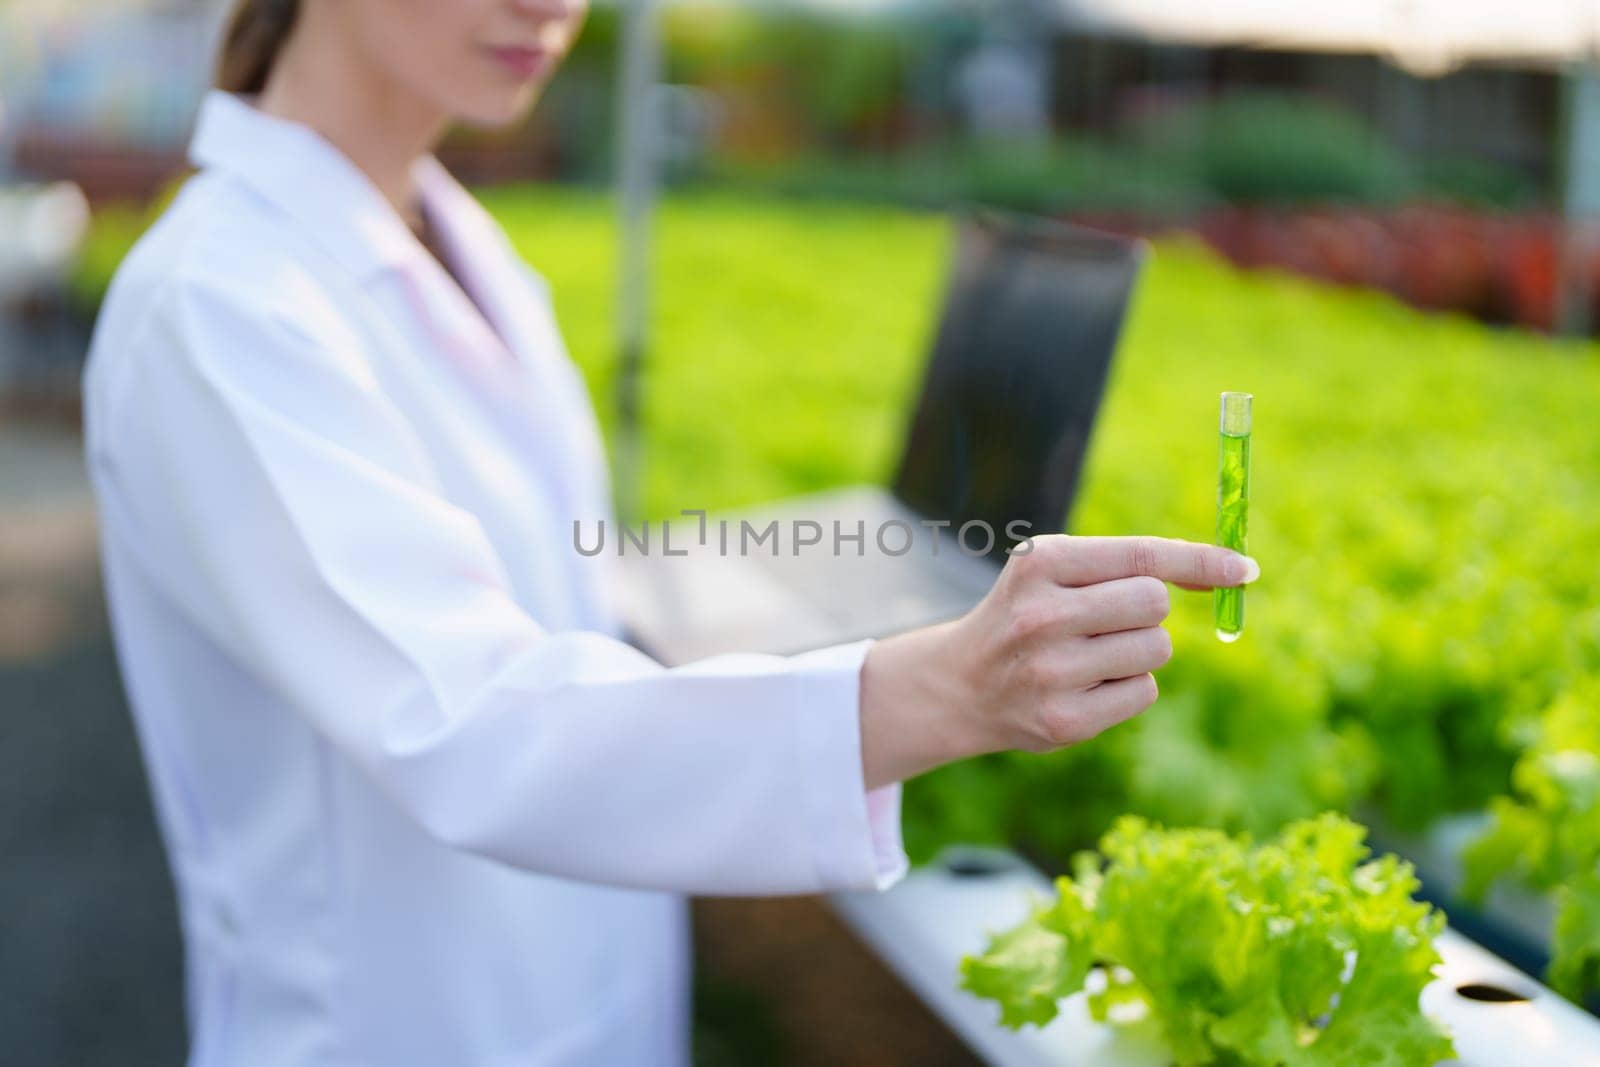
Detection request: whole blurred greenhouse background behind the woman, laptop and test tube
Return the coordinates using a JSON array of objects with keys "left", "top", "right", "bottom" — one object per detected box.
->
[{"left": 0, "top": 0, "right": 1600, "bottom": 1064}]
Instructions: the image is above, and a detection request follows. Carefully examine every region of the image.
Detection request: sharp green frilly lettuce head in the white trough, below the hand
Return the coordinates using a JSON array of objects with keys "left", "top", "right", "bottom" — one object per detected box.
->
[{"left": 962, "top": 814, "right": 1453, "bottom": 1067}]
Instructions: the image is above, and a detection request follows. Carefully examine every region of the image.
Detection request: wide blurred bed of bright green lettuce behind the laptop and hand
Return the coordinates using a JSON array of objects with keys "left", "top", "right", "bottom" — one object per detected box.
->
[{"left": 84, "top": 187, "right": 1600, "bottom": 966}]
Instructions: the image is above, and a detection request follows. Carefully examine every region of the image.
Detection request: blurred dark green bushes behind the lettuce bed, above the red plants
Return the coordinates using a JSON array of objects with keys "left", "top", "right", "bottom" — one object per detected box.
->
[{"left": 709, "top": 89, "right": 1538, "bottom": 218}]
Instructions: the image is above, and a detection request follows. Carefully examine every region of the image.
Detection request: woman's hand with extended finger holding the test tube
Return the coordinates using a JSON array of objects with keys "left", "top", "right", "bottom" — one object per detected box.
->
[{"left": 861, "top": 534, "right": 1261, "bottom": 789}]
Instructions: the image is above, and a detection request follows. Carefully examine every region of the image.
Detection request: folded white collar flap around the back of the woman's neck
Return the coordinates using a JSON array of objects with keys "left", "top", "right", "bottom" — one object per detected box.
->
[{"left": 189, "top": 90, "right": 437, "bottom": 280}]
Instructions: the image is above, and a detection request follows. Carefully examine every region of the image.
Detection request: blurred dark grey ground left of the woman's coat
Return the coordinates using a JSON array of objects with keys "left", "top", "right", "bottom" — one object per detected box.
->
[{"left": 0, "top": 419, "right": 186, "bottom": 1067}]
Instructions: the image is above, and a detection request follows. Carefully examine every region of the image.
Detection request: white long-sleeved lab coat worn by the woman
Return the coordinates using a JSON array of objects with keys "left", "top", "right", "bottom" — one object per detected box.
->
[{"left": 85, "top": 93, "right": 904, "bottom": 1067}]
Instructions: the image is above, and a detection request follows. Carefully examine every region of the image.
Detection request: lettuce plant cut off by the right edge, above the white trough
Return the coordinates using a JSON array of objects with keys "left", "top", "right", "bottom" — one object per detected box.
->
[{"left": 1462, "top": 678, "right": 1600, "bottom": 1000}]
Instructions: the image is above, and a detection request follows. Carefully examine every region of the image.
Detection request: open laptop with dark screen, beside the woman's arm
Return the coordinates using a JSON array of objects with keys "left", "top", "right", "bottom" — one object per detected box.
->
[{"left": 606, "top": 208, "right": 1146, "bottom": 665}]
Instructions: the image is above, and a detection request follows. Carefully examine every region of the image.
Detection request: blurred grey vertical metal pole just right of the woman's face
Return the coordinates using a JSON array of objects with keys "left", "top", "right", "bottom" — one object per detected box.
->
[{"left": 613, "top": 0, "right": 661, "bottom": 523}]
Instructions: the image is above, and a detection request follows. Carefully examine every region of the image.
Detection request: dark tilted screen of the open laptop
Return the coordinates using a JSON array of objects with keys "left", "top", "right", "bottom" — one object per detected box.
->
[{"left": 894, "top": 210, "right": 1144, "bottom": 561}]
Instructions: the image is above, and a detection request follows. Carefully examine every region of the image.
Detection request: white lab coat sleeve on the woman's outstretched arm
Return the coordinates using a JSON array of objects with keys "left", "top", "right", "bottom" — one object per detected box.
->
[{"left": 93, "top": 278, "right": 906, "bottom": 894}]
